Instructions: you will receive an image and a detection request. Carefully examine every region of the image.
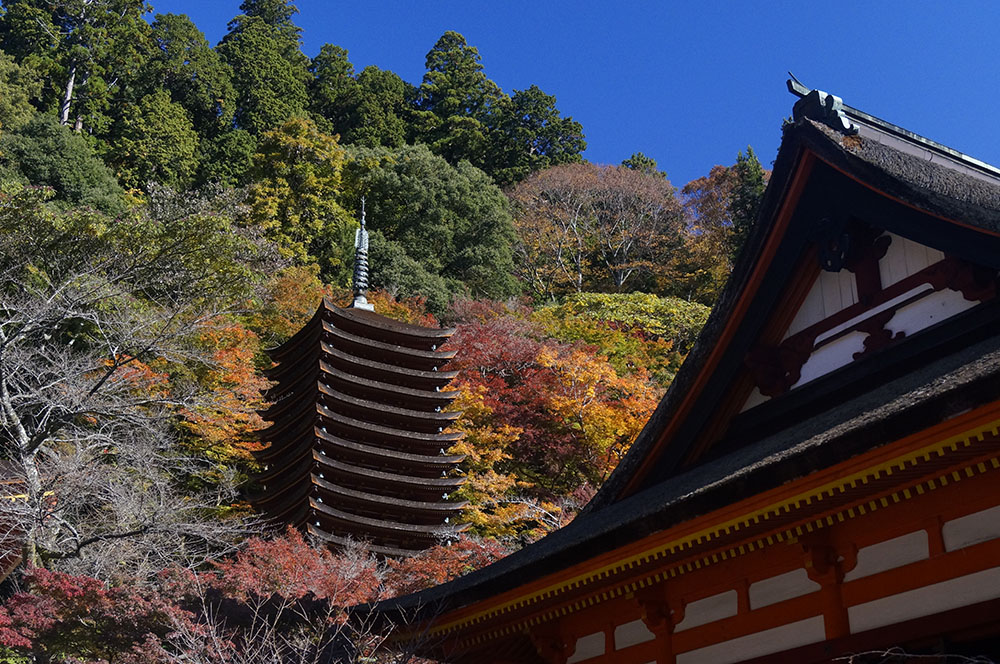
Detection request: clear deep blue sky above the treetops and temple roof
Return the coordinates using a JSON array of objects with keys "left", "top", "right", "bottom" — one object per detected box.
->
[{"left": 151, "top": 0, "right": 1000, "bottom": 187}]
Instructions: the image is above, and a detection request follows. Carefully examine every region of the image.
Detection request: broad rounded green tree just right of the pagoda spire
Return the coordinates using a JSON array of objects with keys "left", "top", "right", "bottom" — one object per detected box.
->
[{"left": 347, "top": 145, "right": 519, "bottom": 298}]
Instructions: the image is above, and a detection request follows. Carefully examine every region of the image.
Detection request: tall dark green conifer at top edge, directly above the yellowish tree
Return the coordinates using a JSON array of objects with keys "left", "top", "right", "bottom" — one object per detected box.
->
[{"left": 218, "top": 8, "right": 310, "bottom": 134}]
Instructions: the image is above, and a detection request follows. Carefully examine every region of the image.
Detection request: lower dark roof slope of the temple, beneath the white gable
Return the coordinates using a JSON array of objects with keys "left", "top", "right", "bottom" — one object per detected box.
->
[{"left": 377, "top": 330, "right": 1000, "bottom": 613}]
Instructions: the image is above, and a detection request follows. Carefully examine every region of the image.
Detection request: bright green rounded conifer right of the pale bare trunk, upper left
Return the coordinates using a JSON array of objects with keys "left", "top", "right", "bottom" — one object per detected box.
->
[{"left": 108, "top": 89, "right": 198, "bottom": 189}]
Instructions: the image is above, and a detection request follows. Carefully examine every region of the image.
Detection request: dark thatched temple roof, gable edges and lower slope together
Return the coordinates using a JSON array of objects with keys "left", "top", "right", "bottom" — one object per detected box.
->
[{"left": 359, "top": 83, "right": 1000, "bottom": 614}]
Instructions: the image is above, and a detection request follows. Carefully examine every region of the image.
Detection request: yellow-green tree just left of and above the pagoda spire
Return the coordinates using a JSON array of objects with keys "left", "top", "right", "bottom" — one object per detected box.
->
[{"left": 250, "top": 118, "right": 355, "bottom": 274}]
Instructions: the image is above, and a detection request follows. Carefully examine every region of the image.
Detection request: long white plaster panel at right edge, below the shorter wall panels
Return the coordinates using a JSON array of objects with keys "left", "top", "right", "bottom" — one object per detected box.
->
[{"left": 847, "top": 567, "right": 1000, "bottom": 634}]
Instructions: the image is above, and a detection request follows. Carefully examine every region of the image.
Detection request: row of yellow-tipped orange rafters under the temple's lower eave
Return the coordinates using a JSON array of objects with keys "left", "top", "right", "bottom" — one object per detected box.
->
[{"left": 431, "top": 403, "right": 1000, "bottom": 649}]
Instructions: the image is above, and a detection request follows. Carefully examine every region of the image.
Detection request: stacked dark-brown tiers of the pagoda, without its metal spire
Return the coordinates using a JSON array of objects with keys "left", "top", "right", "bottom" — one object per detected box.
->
[{"left": 253, "top": 300, "right": 465, "bottom": 556}]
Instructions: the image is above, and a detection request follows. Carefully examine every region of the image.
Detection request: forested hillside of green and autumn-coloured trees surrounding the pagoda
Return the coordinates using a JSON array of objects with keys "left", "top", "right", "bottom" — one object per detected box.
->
[{"left": 0, "top": 0, "right": 767, "bottom": 662}]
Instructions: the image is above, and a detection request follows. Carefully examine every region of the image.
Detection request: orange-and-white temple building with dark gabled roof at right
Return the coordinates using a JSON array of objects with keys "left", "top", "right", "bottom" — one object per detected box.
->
[{"left": 368, "top": 80, "right": 1000, "bottom": 664}]
